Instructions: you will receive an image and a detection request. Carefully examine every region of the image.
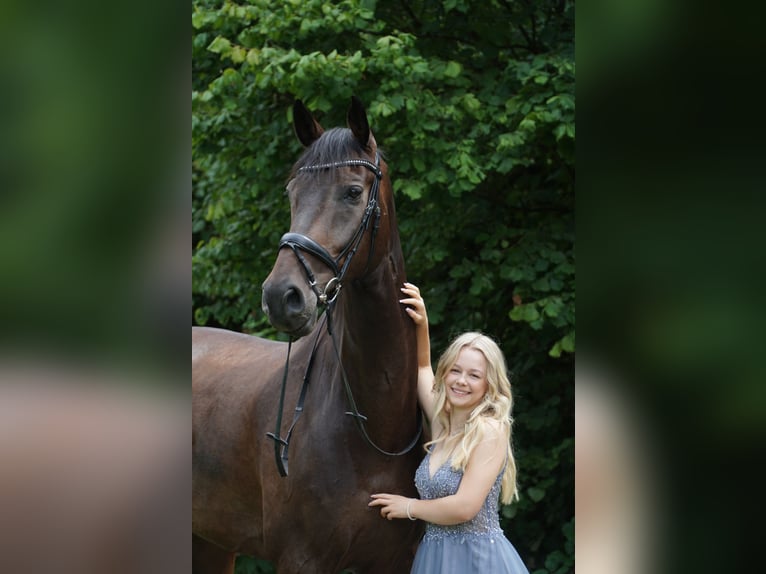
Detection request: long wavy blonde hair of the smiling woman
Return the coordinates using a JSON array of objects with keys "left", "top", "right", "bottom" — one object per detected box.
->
[{"left": 425, "top": 332, "right": 519, "bottom": 504}]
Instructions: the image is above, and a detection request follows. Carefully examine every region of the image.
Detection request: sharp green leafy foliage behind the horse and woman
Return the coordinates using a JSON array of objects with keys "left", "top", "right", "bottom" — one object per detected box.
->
[{"left": 192, "top": 0, "right": 575, "bottom": 574}]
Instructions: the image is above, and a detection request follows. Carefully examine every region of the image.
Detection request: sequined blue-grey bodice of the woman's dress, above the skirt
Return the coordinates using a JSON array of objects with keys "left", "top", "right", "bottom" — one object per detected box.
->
[{"left": 415, "top": 453, "right": 503, "bottom": 541}]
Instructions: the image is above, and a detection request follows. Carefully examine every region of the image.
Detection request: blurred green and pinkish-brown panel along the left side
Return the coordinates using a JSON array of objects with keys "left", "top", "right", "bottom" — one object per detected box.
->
[{"left": 0, "top": 0, "right": 191, "bottom": 574}]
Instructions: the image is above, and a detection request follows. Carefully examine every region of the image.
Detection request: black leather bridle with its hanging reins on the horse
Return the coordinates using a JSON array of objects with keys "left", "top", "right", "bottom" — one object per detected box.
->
[{"left": 266, "top": 152, "right": 423, "bottom": 477}]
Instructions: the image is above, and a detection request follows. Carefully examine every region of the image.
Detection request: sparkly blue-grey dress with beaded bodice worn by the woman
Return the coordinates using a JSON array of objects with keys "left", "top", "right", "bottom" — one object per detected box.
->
[{"left": 411, "top": 453, "right": 529, "bottom": 574}]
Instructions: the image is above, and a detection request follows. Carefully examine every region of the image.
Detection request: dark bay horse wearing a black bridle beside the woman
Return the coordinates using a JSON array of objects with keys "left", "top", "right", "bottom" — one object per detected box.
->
[{"left": 192, "top": 98, "right": 423, "bottom": 574}]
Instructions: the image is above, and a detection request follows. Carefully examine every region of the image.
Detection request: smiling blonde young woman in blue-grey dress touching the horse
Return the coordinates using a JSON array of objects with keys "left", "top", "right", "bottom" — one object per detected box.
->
[{"left": 369, "top": 283, "right": 528, "bottom": 574}]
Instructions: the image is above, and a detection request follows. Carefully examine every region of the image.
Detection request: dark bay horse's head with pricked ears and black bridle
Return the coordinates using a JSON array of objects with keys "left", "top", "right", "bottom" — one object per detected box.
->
[{"left": 262, "top": 98, "right": 390, "bottom": 338}]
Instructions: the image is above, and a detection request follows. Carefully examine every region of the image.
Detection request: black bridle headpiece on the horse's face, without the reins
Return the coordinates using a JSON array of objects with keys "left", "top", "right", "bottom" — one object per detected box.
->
[{"left": 279, "top": 152, "right": 383, "bottom": 305}]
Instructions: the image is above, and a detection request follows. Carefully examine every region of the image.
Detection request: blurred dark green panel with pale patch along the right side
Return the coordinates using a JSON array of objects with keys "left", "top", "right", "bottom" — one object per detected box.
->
[{"left": 576, "top": 0, "right": 766, "bottom": 573}]
